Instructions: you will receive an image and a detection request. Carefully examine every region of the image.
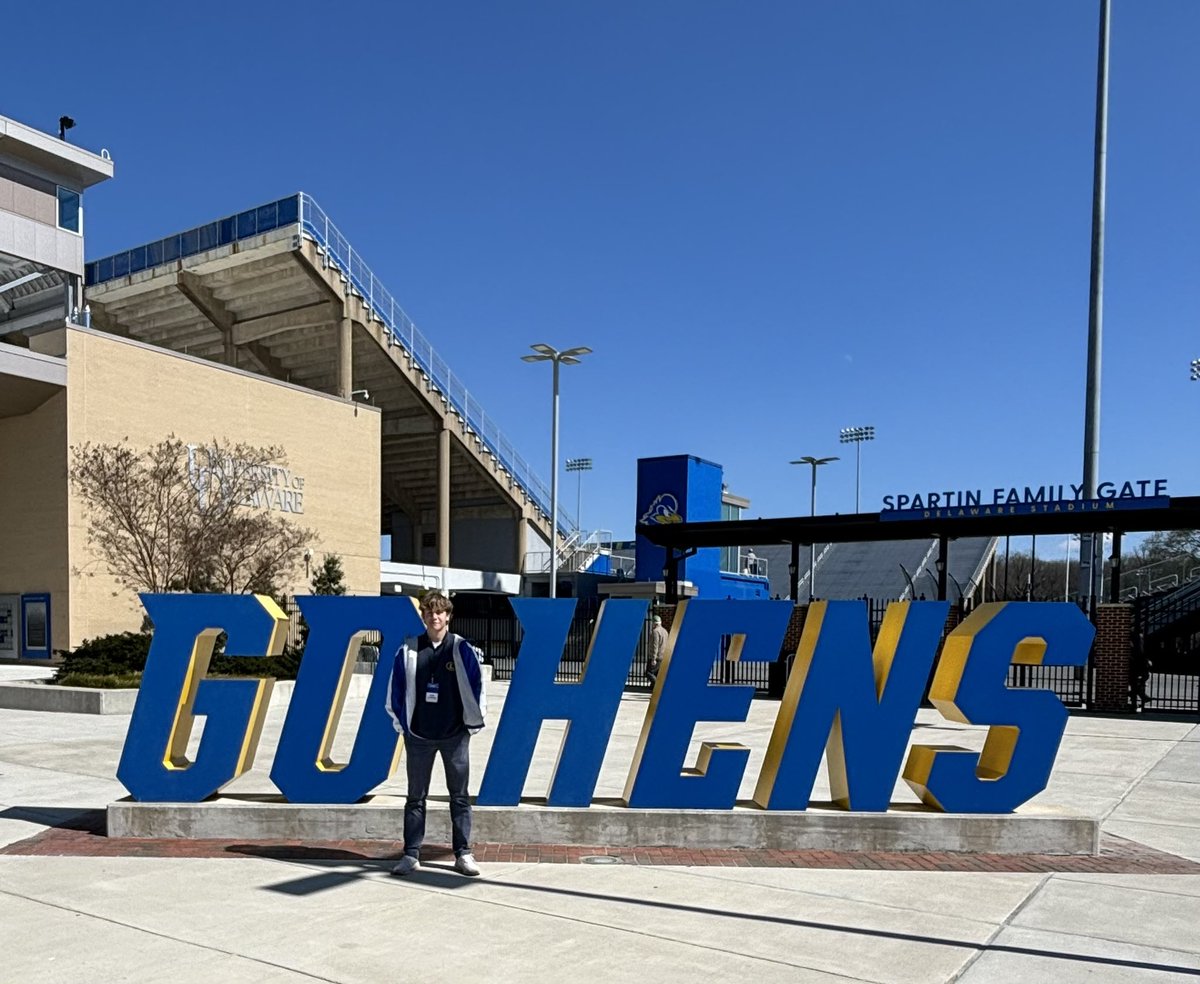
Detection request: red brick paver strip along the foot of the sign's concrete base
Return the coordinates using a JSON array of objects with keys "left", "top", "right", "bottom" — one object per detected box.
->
[{"left": 0, "top": 810, "right": 1200, "bottom": 875}]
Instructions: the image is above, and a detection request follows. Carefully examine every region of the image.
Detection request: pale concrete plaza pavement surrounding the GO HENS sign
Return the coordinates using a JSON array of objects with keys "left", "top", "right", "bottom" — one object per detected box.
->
[{"left": 0, "top": 666, "right": 1200, "bottom": 984}]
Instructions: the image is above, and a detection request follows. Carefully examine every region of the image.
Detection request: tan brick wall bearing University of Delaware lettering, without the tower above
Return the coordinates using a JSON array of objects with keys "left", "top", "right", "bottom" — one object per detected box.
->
[{"left": 0, "top": 326, "right": 380, "bottom": 658}]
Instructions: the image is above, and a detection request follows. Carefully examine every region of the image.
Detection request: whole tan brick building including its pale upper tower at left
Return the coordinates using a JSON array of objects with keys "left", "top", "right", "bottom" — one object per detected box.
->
[{"left": 0, "top": 116, "right": 380, "bottom": 660}]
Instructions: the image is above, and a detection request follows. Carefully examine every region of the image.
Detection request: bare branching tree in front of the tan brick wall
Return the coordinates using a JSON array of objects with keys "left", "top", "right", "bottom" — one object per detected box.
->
[{"left": 68, "top": 434, "right": 316, "bottom": 594}]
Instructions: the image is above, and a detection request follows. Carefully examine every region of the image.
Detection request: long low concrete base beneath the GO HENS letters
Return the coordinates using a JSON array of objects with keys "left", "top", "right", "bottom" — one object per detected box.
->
[{"left": 108, "top": 796, "right": 1100, "bottom": 854}]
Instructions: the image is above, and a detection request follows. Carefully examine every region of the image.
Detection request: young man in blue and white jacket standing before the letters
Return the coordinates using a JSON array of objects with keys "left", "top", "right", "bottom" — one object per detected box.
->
[{"left": 388, "top": 592, "right": 486, "bottom": 875}]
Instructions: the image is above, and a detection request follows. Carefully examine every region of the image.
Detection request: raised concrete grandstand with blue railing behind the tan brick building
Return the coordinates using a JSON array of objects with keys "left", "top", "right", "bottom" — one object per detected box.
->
[{"left": 85, "top": 193, "right": 575, "bottom": 587}]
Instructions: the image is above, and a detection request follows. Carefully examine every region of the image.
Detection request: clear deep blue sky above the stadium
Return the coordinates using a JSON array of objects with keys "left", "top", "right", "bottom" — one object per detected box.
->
[{"left": 11, "top": 0, "right": 1200, "bottom": 535}]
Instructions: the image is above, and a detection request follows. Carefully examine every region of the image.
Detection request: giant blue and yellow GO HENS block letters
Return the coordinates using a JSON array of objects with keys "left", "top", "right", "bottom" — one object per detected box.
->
[{"left": 116, "top": 594, "right": 1094, "bottom": 814}]
